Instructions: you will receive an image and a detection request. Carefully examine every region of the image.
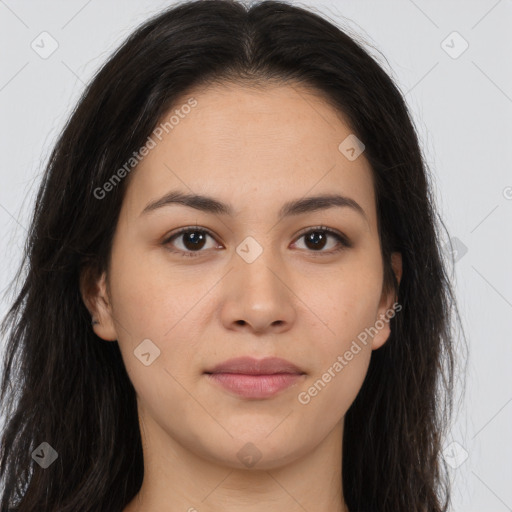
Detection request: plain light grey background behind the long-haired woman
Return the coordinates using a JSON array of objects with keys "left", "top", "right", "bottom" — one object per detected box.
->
[{"left": 0, "top": 0, "right": 512, "bottom": 512}]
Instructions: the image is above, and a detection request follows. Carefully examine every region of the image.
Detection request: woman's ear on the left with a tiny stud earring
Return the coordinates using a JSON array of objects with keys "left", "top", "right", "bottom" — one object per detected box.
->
[{"left": 80, "top": 267, "right": 118, "bottom": 341}]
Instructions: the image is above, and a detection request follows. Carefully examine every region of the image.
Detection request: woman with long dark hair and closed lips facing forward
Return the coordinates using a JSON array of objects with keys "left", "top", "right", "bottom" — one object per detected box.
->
[{"left": 0, "top": 0, "right": 464, "bottom": 512}]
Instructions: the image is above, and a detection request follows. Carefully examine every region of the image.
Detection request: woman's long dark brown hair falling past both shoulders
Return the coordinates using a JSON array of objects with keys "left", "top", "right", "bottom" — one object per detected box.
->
[{"left": 0, "top": 0, "right": 460, "bottom": 512}]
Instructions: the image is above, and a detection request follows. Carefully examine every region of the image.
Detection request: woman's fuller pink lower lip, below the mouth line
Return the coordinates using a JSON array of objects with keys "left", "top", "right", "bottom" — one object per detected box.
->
[{"left": 207, "top": 373, "right": 303, "bottom": 398}]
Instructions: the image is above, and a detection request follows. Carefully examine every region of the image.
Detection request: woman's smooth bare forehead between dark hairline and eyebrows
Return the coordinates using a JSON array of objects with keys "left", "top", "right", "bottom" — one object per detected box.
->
[{"left": 120, "top": 85, "right": 375, "bottom": 226}]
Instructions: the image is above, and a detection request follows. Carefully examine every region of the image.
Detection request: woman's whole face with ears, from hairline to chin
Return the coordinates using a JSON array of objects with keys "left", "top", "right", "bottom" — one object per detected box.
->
[{"left": 87, "top": 85, "right": 401, "bottom": 469}]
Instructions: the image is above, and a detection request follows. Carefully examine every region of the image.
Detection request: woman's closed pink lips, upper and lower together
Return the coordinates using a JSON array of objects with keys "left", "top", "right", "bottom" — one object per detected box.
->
[{"left": 205, "top": 357, "right": 305, "bottom": 399}]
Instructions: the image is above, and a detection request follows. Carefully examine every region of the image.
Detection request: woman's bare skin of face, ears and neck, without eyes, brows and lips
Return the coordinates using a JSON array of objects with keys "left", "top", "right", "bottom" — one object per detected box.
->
[{"left": 82, "top": 84, "right": 402, "bottom": 512}]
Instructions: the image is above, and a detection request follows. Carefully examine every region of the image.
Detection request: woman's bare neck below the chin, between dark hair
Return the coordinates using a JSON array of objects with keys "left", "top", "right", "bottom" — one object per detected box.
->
[{"left": 124, "top": 417, "right": 349, "bottom": 512}]
